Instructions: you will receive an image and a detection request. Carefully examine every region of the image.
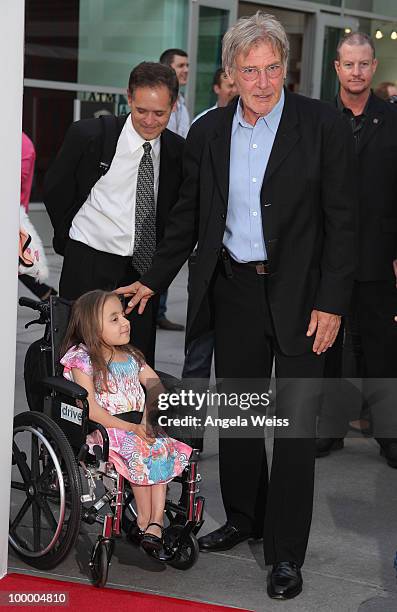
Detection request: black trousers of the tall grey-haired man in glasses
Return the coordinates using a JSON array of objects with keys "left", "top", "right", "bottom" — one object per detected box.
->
[{"left": 212, "top": 265, "right": 324, "bottom": 566}]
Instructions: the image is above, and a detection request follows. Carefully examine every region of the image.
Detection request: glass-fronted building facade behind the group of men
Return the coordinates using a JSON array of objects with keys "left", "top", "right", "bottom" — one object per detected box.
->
[{"left": 23, "top": 0, "right": 397, "bottom": 202}]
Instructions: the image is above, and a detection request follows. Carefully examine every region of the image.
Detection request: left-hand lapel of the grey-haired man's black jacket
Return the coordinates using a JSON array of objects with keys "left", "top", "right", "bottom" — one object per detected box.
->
[{"left": 209, "top": 101, "right": 237, "bottom": 208}]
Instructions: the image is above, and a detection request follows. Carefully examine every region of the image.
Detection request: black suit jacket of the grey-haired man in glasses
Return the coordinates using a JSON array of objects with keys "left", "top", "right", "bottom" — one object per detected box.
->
[{"left": 141, "top": 91, "right": 355, "bottom": 354}]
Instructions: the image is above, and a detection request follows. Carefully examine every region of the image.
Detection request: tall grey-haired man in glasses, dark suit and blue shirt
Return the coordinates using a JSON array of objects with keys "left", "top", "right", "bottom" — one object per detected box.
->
[{"left": 116, "top": 12, "right": 354, "bottom": 599}]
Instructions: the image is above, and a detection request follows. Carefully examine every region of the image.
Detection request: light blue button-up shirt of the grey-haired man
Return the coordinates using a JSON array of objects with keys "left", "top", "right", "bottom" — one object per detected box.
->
[{"left": 223, "top": 90, "right": 284, "bottom": 263}]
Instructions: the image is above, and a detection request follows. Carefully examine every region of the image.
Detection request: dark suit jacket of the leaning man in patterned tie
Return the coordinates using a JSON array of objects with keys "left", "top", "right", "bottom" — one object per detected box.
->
[{"left": 44, "top": 115, "right": 185, "bottom": 255}]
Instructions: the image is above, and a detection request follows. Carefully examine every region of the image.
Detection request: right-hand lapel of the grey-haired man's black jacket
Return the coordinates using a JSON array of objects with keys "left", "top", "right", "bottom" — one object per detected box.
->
[{"left": 263, "top": 90, "right": 300, "bottom": 184}]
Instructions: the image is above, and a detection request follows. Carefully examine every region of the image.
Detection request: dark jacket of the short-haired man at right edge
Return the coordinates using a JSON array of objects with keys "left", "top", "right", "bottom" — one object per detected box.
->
[{"left": 344, "top": 93, "right": 397, "bottom": 281}]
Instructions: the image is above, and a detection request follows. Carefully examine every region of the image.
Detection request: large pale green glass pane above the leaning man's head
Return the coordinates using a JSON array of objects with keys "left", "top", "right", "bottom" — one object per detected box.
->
[{"left": 78, "top": 0, "right": 188, "bottom": 87}]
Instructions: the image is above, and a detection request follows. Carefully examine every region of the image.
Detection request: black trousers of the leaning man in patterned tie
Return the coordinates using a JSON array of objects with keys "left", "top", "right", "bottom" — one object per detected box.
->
[{"left": 59, "top": 240, "right": 158, "bottom": 367}]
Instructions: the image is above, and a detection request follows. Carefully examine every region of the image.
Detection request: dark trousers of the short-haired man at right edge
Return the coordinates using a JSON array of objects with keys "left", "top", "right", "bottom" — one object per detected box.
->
[{"left": 319, "top": 281, "right": 397, "bottom": 444}]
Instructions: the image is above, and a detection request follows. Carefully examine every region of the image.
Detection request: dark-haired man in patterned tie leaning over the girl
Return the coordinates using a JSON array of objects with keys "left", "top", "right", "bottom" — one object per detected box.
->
[{"left": 44, "top": 62, "right": 185, "bottom": 365}]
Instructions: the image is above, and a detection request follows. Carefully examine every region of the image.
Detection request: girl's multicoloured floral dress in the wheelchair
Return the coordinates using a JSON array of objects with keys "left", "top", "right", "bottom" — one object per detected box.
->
[{"left": 61, "top": 344, "right": 192, "bottom": 485}]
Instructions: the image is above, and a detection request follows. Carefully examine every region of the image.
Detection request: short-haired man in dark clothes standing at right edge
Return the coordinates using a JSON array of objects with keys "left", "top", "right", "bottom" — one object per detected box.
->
[{"left": 317, "top": 32, "right": 397, "bottom": 468}]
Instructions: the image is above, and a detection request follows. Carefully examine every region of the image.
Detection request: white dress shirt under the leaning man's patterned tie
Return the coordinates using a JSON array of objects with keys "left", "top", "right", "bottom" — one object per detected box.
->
[{"left": 69, "top": 116, "right": 160, "bottom": 256}]
